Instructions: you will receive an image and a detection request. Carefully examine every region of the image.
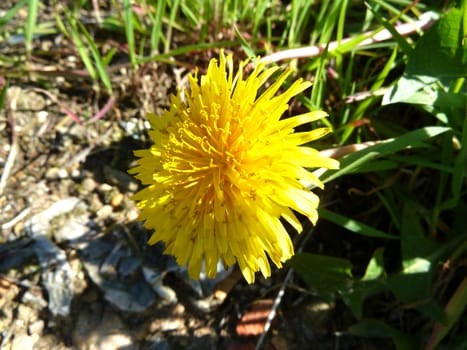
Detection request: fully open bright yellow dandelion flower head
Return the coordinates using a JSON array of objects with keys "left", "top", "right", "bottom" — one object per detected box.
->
[{"left": 130, "top": 53, "right": 339, "bottom": 283}]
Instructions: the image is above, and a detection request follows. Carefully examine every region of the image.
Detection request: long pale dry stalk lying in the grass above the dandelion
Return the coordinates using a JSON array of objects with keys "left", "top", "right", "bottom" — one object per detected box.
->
[{"left": 260, "top": 16, "right": 435, "bottom": 63}]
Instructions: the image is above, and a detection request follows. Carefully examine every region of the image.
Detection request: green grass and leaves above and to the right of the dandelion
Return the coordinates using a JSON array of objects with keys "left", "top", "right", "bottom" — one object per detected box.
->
[{"left": 0, "top": 0, "right": 467, "bottom": 349}]
